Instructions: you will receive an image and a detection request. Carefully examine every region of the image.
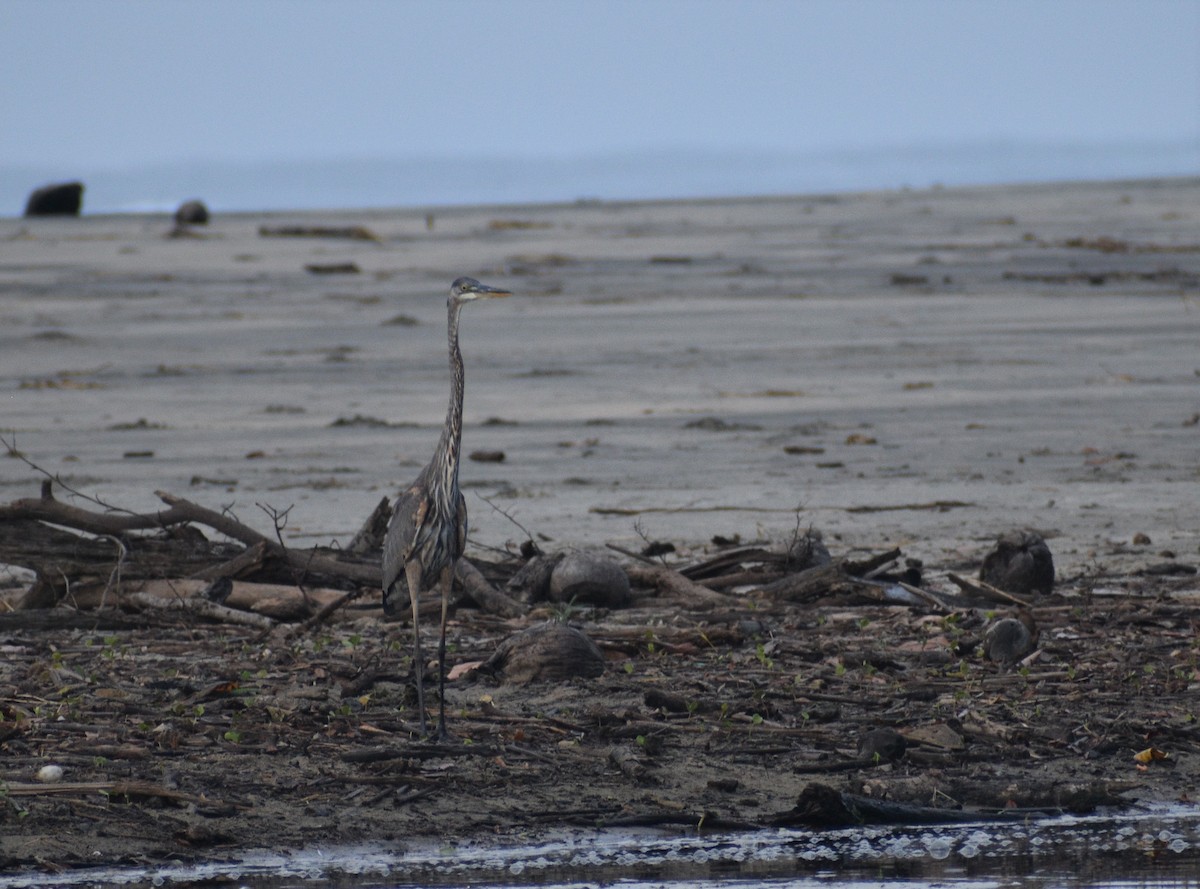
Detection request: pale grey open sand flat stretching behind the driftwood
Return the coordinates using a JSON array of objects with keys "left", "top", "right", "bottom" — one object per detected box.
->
[{"left": 0, "top": 180, "right": 1200, "bottom": 571}]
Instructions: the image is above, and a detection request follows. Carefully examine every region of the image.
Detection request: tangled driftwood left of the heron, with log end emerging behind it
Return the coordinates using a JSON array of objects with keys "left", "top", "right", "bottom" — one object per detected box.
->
[{"left": 0, "top": 481, "right": 535, "bottom": 629}]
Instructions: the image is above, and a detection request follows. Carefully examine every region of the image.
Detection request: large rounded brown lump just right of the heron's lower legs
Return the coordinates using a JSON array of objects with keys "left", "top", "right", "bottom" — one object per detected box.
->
[{"left": 479, "top": 621, "right": 604, "bottom": 685}]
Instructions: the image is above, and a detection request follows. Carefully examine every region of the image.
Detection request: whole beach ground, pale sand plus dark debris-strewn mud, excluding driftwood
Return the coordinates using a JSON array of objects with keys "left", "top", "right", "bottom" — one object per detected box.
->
[{"left": 0, "top": 179, "right": 1200, "bottom": 866}]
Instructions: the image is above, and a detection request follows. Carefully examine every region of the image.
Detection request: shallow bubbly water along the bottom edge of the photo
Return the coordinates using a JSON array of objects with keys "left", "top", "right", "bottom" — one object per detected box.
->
[{"left": 14, "top": 805, "right": 1200, "bottom": 889}]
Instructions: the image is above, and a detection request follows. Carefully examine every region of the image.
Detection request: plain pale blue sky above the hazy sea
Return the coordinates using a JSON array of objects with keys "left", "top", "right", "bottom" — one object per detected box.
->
[{"left": 0, "top": 0, "right": 1200, "bottom": 168}]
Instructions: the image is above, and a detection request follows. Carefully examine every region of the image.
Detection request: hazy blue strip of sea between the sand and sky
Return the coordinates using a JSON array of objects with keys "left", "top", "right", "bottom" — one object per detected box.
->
[{"left": 0, "top": 139, "right": 1200, "bottom": 216}]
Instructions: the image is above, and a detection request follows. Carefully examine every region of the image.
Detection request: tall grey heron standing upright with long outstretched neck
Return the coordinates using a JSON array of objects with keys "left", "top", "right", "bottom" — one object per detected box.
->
[{"left": 383, "top": 277, "right": 511, "bottom": 739}]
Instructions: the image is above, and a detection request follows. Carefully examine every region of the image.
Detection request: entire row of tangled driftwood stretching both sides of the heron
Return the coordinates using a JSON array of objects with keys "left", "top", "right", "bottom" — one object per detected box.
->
[{"left": 0, "top": 472, "right": 945, "bottom": 629}]
